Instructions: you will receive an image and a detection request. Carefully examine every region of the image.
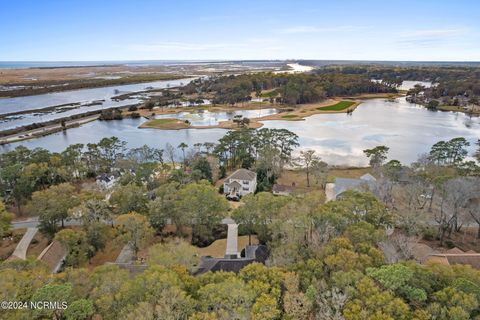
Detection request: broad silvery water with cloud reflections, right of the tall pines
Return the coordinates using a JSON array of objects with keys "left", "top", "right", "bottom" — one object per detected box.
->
[{"left": 264, "top": 98, "right": 480, "bottom": 165}]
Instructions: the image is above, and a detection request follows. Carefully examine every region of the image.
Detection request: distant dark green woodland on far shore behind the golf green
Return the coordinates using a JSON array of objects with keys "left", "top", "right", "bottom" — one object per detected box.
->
[{"left": 183, "top": 65, "right": 480, "bottom": 106}]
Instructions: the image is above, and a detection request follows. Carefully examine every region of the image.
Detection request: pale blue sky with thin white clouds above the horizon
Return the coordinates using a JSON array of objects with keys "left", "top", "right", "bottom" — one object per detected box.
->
[{"left": 0, "top": 0, "right": 480, "bottom": 61}]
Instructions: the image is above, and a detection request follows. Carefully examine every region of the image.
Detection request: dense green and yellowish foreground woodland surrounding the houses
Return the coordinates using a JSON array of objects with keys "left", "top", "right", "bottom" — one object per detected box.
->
[{"left": 0, "top": 129, "right": 480, "bottom": 320}]
